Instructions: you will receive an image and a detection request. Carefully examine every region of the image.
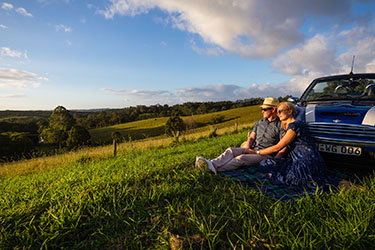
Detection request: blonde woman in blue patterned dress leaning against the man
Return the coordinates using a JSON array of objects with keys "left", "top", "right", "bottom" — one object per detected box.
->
[{"left": 251, "top": 102, "right": 326, "bottom": 190}]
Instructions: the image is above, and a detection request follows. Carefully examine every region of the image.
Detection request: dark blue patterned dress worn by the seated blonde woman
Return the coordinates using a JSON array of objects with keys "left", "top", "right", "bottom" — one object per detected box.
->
[{"left": 259, "top": 121, "right": 326, "bottom": 190}]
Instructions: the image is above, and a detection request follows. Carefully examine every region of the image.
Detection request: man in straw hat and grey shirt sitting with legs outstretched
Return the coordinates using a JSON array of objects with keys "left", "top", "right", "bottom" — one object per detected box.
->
[{"left": 195, "top": 97, "right": 283, "bottom": 173}]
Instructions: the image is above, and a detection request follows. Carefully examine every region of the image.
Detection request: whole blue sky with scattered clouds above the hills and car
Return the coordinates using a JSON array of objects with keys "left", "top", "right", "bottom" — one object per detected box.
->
[{"left": 0, "top": 0, "right": 375, "bottom": 110}]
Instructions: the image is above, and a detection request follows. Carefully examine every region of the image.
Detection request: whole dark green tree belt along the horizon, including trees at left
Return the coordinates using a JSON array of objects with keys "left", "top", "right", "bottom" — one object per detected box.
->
[{"left": 0, "top": 96, "right": 289, "bottom": 162}]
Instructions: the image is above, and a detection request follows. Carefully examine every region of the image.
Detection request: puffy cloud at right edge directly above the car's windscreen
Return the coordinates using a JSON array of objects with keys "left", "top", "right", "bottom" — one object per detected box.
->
[{"left": 272, "top": 20, "right": 375, "bottom": 93}]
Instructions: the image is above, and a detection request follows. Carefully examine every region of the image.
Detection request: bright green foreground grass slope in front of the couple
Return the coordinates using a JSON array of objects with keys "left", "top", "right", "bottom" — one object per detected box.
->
[{"left": 0, "top": 130, "right": 375, "bottom": 249}]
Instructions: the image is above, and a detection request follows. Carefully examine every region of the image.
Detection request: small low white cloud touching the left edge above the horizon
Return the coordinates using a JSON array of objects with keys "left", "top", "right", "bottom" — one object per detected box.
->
[{"left": 0, "top": 68, "right": 48, "bottom": 88}]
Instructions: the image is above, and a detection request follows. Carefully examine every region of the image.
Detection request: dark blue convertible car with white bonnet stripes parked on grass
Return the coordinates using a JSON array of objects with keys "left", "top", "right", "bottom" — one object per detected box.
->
[{"left": 289, "top": 73, "right": 375, "bottom": 169}]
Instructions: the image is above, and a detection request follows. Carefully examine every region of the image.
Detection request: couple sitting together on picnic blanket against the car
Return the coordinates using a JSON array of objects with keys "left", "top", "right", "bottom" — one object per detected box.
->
[{"left": 195, "top": 97, "right": 326, "bottom": 189}]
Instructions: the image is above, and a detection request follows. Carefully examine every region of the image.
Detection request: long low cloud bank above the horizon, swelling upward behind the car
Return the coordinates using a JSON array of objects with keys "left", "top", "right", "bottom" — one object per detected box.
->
[{"left": 105, "top": 16, "right": 375, "bottom": 105}]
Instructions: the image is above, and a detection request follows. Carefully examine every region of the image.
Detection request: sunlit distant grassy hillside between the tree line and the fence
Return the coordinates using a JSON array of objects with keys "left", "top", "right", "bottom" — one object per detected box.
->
[{"left": 89, "top": 106, "right": 262, "bottom": 144}]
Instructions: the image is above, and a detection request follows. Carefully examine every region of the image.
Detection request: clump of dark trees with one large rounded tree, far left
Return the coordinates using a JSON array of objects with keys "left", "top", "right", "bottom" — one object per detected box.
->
[{"left": 0, "top": 106, "right": 90, "bottom": 162}]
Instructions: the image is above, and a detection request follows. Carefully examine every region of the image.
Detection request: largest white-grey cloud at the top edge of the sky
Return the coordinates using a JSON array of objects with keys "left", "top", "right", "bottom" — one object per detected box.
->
[{"left": 98, "top": 0, "right": 353, "bottom": 58}]
